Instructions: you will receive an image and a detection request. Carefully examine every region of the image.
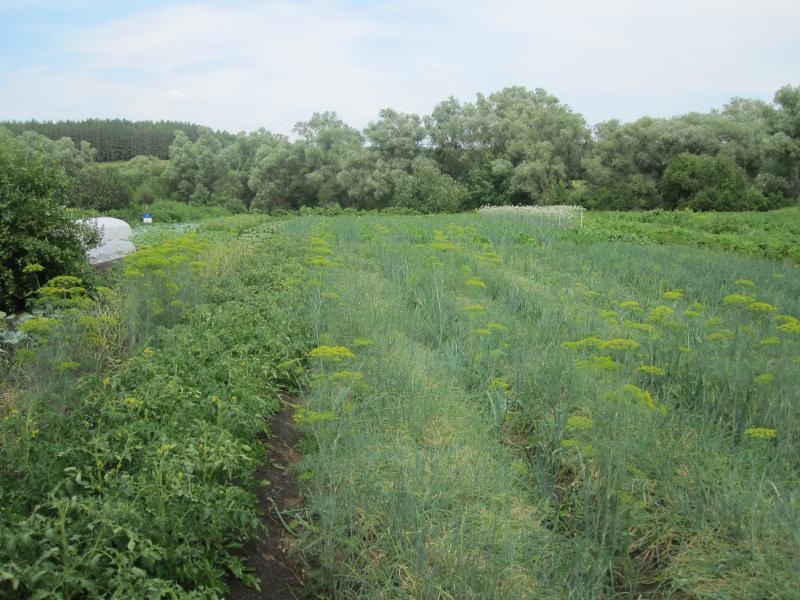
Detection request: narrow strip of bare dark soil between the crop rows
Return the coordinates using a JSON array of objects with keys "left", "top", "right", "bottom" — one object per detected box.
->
[{"left": 227, "top": 398, "right": 305, "bottom": 600}]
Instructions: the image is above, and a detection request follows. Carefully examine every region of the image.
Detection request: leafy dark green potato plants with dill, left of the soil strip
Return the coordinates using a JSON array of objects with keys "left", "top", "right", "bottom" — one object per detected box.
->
[{"left": 0, "top": 223, "right": 305, "bottom": 598}]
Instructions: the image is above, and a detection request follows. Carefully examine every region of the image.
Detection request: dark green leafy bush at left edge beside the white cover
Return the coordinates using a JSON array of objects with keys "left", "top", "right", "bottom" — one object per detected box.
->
[{"left": 0, "top": 137, "right": 98, "bottom": 311}]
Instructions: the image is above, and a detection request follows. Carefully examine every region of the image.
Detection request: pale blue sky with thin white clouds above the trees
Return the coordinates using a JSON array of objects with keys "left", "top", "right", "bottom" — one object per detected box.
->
[{"left": 0, "top": 0, "right": 800, "bottom": 133}]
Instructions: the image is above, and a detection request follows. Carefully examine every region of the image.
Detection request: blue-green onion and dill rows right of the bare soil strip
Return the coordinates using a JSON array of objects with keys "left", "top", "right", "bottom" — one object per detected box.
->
[{"left": 289, "top": 215, "right": 800, "bottom": 598}]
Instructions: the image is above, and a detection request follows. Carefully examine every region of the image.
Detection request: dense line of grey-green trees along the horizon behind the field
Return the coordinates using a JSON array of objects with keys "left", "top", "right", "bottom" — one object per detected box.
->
[{"left": 0, "top": 86, "right": 800, "bottom": 212}]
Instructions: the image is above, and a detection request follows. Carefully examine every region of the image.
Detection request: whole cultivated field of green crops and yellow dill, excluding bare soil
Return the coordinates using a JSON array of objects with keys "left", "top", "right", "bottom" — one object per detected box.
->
[{"left": 0, "top": 209, "right": 800, "bottom": 599}]
